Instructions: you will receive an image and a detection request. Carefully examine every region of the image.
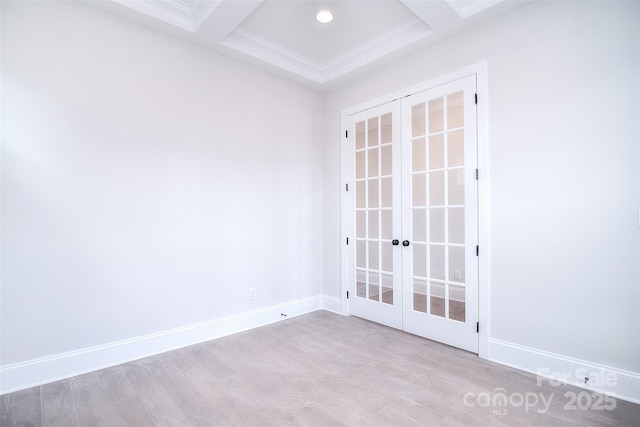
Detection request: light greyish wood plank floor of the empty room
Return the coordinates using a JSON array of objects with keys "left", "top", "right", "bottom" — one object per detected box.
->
[{"left": 0, "top": 311, "right": 640, "bottom": 426}]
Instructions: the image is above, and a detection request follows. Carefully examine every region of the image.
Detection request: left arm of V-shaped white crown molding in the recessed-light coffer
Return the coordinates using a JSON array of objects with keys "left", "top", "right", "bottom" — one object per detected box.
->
[{"left": 221, "top": 27, "right": 324, "bottom": 83}]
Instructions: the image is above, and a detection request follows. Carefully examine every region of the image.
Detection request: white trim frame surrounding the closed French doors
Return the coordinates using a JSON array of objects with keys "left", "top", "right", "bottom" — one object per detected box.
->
[{"left": 340, "top": 61, "right": 491, "bottom": 359}]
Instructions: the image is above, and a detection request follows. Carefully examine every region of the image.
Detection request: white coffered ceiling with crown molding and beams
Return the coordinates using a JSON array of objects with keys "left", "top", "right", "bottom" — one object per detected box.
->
[{"left": 84, "top": 0, "right": 531, "bottom": 87}]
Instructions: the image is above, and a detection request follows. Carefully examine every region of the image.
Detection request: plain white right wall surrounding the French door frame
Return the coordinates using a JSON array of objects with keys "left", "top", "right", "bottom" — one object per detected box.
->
[{"left": 324, "top": 2, "right": 640, "bottom": 374}]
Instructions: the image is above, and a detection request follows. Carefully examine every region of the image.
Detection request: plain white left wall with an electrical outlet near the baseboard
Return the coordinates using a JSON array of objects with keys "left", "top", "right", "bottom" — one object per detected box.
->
[{"left": 0, "top": 1, "right": 322, "bottom": 365}]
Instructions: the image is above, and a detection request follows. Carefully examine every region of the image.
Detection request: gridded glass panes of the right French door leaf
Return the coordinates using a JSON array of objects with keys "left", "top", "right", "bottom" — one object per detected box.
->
[{"left": 410, "top": 92, "right": 466, "bottom": 321}]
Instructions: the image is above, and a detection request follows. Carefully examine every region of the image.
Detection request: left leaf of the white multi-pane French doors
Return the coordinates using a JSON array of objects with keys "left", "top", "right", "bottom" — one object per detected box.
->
[{"left": 347, "top": 102, "right": 402, "bottom": 328}]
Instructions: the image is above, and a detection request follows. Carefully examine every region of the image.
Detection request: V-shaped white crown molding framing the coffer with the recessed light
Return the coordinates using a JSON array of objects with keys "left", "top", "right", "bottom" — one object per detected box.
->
[{"left": 222, "top": 18, "right": 433, "bottom": 84}]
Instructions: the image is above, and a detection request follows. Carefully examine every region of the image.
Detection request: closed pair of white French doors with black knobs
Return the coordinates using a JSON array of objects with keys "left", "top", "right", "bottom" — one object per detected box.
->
[{"left": 347, "top": 75, "right": 478, "bottom": 352}]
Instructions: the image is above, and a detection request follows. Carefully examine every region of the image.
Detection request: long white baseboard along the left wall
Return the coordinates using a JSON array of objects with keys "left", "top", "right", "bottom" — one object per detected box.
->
[{"left": 0, "top": 295, "right": 330, "bottom": 395}]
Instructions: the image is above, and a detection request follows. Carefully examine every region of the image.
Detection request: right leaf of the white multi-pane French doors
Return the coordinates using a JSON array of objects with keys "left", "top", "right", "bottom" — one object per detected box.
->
[{"left": 402, "top": 76, "right": 478, "bottom": 352}]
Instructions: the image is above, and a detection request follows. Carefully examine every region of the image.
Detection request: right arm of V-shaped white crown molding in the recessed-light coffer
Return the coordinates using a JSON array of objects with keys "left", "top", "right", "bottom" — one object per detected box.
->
[{"left": 322, "top": 18, "right": 434, "bottom": 81}]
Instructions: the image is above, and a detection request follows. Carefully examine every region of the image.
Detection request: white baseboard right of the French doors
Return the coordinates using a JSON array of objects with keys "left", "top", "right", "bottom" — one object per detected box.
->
[{"left": 488, "top": 338, "right": 640, "bottom": 403}]
